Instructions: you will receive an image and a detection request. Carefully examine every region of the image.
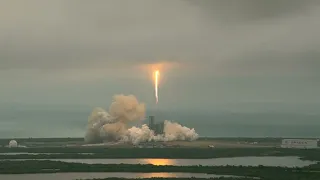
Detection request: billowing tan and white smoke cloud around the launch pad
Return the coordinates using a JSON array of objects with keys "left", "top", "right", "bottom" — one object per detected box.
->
[{"left": 85, "top": 95, "right": 198, "bottom": 144}]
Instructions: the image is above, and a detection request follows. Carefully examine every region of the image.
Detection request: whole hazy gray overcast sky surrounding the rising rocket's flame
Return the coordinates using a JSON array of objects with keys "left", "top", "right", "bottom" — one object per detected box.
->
[{"left": 0, "top": 0, "right": 320, "bottom": 109}]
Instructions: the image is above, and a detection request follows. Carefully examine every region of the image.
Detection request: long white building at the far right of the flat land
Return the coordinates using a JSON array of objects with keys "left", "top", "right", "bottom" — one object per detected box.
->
[{"left": 281, "top": 139, "right": 318, "bottom": 149}]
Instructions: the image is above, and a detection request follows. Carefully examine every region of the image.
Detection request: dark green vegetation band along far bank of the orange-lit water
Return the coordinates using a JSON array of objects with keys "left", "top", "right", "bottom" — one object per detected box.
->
[{"left": 0, "top": 147, "right": 320, "bottom": 160}]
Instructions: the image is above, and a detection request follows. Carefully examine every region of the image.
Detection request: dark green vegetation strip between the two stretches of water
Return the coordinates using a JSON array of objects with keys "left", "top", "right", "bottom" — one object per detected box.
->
[{"left": 0, "top": 160, "right": 320, "bottom": 180}]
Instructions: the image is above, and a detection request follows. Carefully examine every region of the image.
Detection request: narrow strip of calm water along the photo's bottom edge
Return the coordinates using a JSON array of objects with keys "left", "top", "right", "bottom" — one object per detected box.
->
[{"left": 0, "top": 172, "right": 238, "bottom": 180}]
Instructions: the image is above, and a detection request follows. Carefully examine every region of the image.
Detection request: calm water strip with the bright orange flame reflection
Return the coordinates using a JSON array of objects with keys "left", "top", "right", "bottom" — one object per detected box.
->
[{"left": 6, "top": 156, "right": 315, "bottom": 167}]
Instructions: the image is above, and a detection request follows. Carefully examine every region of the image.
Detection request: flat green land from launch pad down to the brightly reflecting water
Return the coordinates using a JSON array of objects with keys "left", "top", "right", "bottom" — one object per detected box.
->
[{"left": 0, "top": 138, "right": 320, "bottom": 160}]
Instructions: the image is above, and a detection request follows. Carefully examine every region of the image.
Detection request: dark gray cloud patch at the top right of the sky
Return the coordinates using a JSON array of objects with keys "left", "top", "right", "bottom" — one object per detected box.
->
[{"left": 188, "top": 0, "right": 320, "bottom": 24}]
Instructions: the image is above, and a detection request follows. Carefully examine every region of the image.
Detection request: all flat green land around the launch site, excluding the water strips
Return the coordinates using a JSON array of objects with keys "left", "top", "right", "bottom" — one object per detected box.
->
[{"left": 0, "top": 138, "right": 320, "bottom": 180}]
